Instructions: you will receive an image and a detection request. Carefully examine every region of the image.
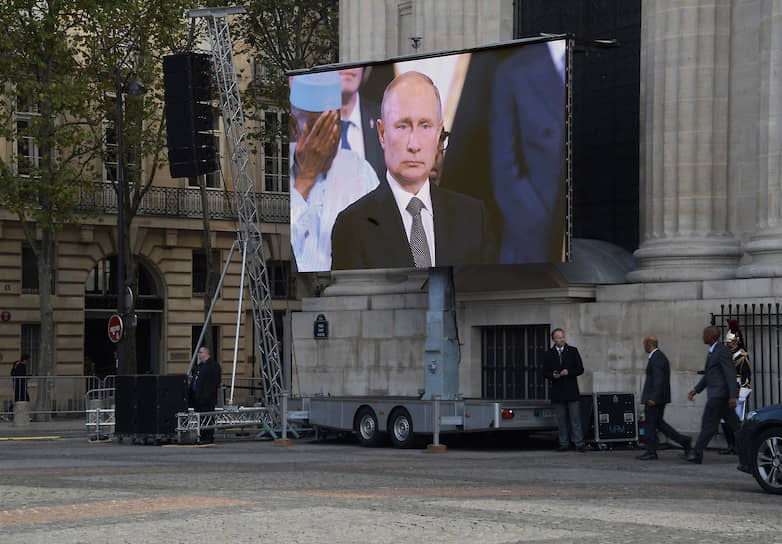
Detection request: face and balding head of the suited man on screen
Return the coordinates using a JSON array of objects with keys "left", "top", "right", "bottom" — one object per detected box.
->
[{"left": 378, "top": 79, "right": 442, "bottom": 192}]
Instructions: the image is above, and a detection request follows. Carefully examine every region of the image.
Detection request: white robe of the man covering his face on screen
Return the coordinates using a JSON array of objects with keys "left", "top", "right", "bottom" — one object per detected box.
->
[{"left": 290, "top": 144, "right": 380, "bottom": 272}]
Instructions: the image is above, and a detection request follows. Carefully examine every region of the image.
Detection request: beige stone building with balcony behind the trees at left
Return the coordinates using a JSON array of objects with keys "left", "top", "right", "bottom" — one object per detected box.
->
[{"left": 0, "top": 51, "right": 306, "bottom": 382}]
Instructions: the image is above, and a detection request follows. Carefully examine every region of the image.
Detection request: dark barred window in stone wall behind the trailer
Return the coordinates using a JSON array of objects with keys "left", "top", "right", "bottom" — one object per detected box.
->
[{"left": 481, "top": 325, "right": 550, "bottom": 400}]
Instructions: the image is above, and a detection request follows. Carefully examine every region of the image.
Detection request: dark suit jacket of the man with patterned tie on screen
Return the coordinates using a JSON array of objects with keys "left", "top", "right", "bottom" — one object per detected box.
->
[{"left": 331, "top": 180, "right": 495, "bottom": 270}]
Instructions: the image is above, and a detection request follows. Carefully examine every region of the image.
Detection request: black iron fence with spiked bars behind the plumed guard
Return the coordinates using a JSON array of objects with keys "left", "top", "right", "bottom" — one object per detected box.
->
[{"left": 711, "top": 302, "right": 782, "bottom": 410}]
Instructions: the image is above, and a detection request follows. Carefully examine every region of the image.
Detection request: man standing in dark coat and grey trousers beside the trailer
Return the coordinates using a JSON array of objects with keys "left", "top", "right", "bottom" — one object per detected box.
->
[{"left": 543, "top": 329, "right": 586, "bottom": 452}]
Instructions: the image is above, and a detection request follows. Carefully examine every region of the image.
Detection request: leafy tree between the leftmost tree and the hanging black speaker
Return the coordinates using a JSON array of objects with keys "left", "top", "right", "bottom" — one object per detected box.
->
[{"left": 79, "top": 0, "right": 208, "bottom": 374}]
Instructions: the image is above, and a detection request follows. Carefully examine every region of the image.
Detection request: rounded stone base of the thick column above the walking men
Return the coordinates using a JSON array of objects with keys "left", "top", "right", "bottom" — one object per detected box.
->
[{"left": 627, "top": 236, "right": 742, "bottom": 283}]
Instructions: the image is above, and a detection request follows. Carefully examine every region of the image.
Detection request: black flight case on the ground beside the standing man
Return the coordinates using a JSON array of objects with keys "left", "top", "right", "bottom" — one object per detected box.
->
[{"left": 581, "top": 392, "right": 638, "bottom": 446}]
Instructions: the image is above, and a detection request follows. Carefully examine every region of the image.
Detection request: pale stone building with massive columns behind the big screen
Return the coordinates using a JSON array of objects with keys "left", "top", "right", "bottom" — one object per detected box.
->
[{"left": 293, "top": 0, "right": 782, "bottom": 431}]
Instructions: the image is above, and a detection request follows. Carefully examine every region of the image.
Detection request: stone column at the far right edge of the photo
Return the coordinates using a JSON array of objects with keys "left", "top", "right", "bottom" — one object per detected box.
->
[{"left": 737, "top": 0, "right": 782, "bottom": 278}]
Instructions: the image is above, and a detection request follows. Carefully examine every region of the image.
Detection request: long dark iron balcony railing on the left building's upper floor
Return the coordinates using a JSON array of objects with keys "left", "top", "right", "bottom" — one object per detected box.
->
[{"left": 79, "top": 182, "right": 290, "bottom": 223}]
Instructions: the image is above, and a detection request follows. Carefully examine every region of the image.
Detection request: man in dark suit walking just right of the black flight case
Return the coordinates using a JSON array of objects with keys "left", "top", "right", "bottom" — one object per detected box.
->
[{"left": 638, "top": 336, "right": 691, "bottom": 461}]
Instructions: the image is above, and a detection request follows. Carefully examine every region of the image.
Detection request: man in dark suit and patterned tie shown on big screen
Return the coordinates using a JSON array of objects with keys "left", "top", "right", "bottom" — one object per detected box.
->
[{"left": 331, "top": 72, "right": 494, "bottom": 270}]
